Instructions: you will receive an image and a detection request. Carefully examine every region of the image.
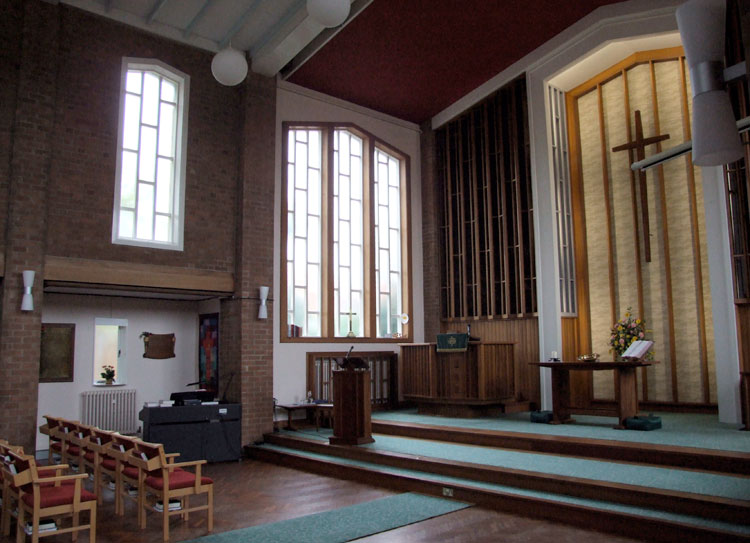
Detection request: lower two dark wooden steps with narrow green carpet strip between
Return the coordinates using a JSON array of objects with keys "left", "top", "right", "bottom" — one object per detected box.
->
[{"left": 251, "top": 433, "right": 750, "bottom": 542}]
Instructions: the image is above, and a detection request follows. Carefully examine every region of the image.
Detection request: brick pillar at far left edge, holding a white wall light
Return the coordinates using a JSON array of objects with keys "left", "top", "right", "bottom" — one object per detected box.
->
[{"left": 0, "top": 2, "right": 59, "bottom": 452}]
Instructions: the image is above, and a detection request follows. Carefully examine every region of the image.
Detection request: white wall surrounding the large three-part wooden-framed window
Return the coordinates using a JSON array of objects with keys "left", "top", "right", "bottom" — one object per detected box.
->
[{"left": 273, "top": 81, "right": 424, "bottom": 403}]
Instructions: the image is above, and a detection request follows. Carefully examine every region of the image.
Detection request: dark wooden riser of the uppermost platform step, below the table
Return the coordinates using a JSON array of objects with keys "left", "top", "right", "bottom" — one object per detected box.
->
[{"left": 372, "top": 419, "right": 750, "bottom": 476}]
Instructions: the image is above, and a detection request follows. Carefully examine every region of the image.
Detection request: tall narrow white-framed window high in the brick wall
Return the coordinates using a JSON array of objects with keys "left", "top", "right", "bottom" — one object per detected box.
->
[{"left": 112, "top": 58, "right": 189, "bottom": 250}]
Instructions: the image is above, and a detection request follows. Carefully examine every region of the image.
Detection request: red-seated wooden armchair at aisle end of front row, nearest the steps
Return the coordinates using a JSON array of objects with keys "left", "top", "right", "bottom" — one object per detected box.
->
[{"left": 131, "top": 441, "right": 214, "bottom": 541}]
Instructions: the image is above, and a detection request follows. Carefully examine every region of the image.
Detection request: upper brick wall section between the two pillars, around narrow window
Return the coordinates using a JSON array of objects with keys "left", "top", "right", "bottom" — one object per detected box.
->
[{"left": 48, "top": 5, "right": 242, "bottom": 272}]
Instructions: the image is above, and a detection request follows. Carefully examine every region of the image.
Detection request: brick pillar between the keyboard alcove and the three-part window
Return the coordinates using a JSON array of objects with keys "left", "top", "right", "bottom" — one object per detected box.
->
[{"left": 221, "top": 73, "right": 277, "bottom": 444}]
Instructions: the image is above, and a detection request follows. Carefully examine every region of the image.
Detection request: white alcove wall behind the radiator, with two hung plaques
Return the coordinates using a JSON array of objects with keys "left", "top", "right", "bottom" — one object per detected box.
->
[{"left": 36, "top": 293, "right": 218, "bottom": 451}]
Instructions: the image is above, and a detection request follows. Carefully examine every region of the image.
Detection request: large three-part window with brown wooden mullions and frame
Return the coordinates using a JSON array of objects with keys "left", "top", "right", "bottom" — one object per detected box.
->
[{"left": 282, "top": 124, "right": 409, "bottom": 340}]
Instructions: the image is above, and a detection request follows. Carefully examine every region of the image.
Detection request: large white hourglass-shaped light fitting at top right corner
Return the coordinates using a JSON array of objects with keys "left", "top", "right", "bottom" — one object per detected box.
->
[{"left": 676, "top": 0, "right": 743, "bottom": 166}]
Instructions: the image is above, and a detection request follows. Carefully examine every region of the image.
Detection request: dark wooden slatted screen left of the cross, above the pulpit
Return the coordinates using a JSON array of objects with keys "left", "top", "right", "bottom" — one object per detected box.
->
[{"left": 436, "top": 78, "right": 537, "bottom": 319}]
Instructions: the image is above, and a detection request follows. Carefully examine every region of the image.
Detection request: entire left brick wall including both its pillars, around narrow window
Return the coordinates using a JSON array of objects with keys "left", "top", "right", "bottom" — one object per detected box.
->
[{"left": 0, "top": 0, "right": 276, "bottom": 450}]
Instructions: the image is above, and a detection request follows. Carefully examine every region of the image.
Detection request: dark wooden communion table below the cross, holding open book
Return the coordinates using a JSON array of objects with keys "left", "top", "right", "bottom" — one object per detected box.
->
[{"left": 531, "top": 362, "right": 653, "bottom": 430}]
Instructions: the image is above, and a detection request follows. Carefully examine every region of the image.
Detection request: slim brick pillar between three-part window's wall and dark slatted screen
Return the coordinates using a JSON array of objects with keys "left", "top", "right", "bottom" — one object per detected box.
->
[{"left": 420, "top": 122, "right": 442, "bottom": 341}]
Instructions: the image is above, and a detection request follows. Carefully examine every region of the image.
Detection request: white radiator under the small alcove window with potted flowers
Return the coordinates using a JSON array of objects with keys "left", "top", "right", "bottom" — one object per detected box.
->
[{"left": 81, "top": 388, "right": 138, "bottom": 434}]
